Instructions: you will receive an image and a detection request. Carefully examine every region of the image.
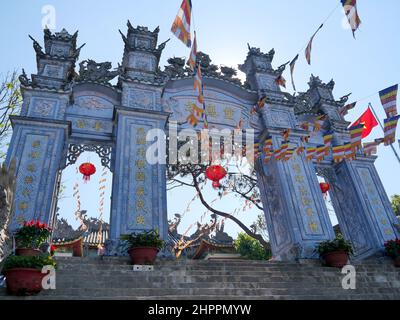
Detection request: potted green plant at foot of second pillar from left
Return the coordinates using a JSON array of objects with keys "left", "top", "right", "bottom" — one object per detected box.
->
[{"left": 121, "top": 230, "right": 164, "bottom": 265}]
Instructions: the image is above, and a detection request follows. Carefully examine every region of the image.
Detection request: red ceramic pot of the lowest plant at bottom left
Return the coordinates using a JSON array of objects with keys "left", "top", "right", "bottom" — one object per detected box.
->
[{"left": 5, "top": 268, "right": 46, "bottom": 296}]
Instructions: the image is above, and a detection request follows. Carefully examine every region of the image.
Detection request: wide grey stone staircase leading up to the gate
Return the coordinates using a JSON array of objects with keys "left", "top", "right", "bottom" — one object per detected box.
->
[{"left": 0, "top": 257, "right": 400, "bottom": 300}]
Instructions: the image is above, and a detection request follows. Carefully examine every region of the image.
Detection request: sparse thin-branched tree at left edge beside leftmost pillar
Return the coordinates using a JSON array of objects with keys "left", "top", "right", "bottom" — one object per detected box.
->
[{"left": 0, "top": 71, "right": 22, "bottom": 160}]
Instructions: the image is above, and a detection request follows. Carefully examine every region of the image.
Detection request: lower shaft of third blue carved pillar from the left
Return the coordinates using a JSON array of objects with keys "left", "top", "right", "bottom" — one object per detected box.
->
[{"left": 258, "top": 131, "right": 334, "bottom": 261}]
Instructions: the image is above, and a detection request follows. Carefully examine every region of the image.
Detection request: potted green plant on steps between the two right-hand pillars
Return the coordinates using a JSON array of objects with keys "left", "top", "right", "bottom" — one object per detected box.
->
[{"left": 317, "top": 234, "right": 353, "bottom": 268}]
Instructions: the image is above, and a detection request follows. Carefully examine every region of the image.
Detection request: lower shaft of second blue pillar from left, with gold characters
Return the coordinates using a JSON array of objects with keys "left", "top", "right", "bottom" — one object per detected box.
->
[{"left": 108, "top": 107, "right": 168, "bottom": 254}]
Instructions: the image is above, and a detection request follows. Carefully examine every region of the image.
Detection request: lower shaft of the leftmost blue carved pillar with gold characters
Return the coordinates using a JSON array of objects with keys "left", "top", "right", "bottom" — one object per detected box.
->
[{"left": 6, "top": 116, "right": 70, "bottom": 230}]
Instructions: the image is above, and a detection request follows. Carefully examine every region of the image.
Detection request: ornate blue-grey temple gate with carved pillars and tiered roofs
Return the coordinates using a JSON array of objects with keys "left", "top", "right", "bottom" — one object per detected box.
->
[{"left": 7, "top": 22, "right": 397, "bottom": 260}]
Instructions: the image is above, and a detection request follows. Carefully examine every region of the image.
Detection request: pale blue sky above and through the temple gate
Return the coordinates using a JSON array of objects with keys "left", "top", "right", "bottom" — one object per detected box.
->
[{"left": 0, "top": 0, "right": 400, "bottom": 238}]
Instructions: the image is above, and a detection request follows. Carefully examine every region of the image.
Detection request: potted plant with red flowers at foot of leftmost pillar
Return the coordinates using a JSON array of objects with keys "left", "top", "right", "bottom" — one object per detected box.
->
[{"left": 14, "top": 220, "right": 51, "bottom": 256}]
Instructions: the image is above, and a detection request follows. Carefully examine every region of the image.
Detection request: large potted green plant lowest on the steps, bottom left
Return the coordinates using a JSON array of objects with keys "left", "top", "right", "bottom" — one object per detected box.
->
[{"left": 2, "top": 254, "right": 56, "bottom": 295}]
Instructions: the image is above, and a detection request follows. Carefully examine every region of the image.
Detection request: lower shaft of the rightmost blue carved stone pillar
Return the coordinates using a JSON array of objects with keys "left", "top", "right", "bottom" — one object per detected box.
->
[{"left": 326, "top": 156, "right": 399, "bottom": 259}]
